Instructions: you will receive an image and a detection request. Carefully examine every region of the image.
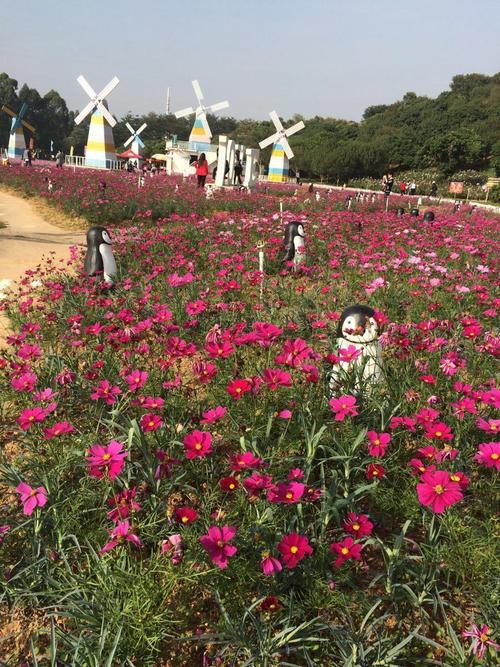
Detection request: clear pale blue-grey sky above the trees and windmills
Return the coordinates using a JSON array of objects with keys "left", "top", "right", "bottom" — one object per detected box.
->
[{"left": 0, "top": 0, "right": 500, "bottom": 120}]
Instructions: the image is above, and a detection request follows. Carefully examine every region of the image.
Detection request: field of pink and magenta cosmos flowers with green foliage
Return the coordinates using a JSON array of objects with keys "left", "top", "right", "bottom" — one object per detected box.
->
[{"left": 0, "top": 167, "right": 500, "bottom": 667}]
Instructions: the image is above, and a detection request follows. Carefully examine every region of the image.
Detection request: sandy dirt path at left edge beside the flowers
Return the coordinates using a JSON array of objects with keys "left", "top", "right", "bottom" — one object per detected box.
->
[{"left": 0, "top": 190, "right": 85, "bottom": 347}]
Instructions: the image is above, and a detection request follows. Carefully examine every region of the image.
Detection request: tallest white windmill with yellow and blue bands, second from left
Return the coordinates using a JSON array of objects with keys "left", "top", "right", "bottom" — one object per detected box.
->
[{"left": 75, "top": 74, "right": 120, "bottom": 169}]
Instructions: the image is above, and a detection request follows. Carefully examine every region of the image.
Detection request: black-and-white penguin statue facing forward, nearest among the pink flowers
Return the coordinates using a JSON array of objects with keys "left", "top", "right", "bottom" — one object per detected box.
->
[{"left": 330, "top": 304, "right": 383, "bottom": 391}]
